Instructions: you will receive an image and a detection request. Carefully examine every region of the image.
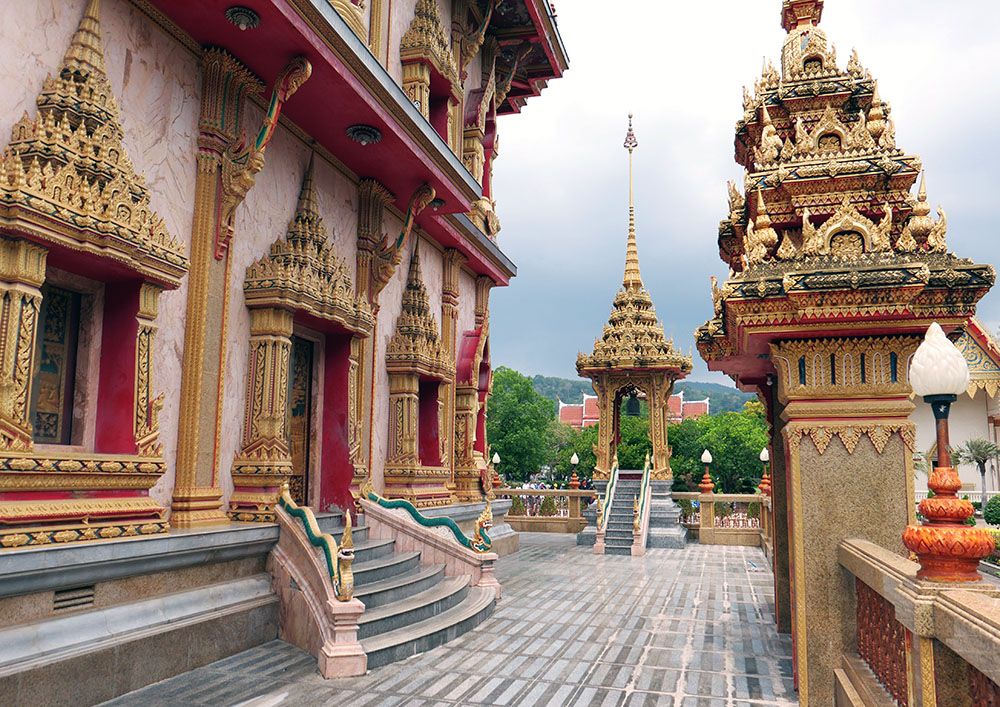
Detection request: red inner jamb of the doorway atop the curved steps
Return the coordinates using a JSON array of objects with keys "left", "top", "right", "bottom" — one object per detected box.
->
[{"left": 319, "top": 335, "right": 354, "bottom": 511}]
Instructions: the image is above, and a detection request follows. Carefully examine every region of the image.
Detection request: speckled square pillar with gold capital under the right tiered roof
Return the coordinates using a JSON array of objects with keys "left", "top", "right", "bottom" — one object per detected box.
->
[{"left": 771, "top": 336, "right": 919, "bottom": 705}]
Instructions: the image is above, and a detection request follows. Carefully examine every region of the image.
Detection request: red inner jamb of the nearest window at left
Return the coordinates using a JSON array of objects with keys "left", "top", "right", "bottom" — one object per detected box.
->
[{"left": 94, "top": 281, "right": 140, "bottom": 454}]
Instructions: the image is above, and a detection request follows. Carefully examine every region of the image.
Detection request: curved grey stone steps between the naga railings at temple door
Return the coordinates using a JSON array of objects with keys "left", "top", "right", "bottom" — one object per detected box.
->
[{"left": 316, "top": 508, "right": 496, "bottom": 669}]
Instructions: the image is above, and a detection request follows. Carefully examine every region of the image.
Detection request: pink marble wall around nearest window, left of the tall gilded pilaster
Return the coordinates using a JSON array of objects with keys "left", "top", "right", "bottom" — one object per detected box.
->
[{"left": 0, "top": 0, "right": 200, "bottom": 503}]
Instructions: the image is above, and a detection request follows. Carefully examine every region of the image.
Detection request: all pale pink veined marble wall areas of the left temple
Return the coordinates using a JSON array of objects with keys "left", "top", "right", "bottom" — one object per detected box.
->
[{"left": 0, "top": 0, "right": 484, "bottom": 506}]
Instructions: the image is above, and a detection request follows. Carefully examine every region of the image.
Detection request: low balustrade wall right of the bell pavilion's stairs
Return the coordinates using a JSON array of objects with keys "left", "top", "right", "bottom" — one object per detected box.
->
[{"left": 672, "top": 491, "right": 772, "bottom": 557}]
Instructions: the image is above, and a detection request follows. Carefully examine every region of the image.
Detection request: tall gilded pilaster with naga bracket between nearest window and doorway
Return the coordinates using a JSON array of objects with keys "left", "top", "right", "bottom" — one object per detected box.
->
[{"left": 170, "top": 49, "right": 311, "bottom": 527}]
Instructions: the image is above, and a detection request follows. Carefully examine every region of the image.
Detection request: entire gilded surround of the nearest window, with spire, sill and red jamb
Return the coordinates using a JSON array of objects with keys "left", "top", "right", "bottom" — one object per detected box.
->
[{"left": 0, "top": 0, "right": 188, "bottom": 547}]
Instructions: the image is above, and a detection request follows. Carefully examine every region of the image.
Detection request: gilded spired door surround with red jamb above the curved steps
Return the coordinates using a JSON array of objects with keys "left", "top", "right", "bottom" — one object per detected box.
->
[{"left": 229, "top": 158, "right": 375, "bottom": 522}]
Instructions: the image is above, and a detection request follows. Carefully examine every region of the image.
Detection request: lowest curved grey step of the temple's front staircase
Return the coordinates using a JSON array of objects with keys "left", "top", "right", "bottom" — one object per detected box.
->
[{"left": 361, "top": 587, "right": 496, "bottom": 669}]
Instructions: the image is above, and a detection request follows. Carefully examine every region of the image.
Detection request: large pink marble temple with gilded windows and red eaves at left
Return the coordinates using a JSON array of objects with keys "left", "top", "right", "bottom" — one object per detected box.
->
[{"left": 0, "top": 0, "right": 568, "bottom": 704}]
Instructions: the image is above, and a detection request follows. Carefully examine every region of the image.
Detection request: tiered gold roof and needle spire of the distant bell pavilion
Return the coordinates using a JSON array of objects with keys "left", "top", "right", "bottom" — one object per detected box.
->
[{"left": 576, "top": 114, "right": 691, "bottom": 374}]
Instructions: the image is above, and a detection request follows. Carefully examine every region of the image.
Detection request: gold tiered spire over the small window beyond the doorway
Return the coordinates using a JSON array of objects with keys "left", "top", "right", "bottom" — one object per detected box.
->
[{"left": 385, "top": 241, "right": 455, "bottom": 380}]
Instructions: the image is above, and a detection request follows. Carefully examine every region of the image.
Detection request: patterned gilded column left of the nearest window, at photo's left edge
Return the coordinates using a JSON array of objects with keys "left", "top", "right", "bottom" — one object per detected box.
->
[{"left": 0, "top": 237, "right": 48, "bottom": 451}]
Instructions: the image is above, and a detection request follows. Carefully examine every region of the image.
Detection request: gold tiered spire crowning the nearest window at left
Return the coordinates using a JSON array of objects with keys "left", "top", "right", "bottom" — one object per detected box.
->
[{"left": 0, "top": 0, "right": 188, "bottom": 287}]
